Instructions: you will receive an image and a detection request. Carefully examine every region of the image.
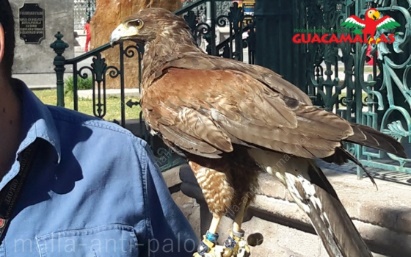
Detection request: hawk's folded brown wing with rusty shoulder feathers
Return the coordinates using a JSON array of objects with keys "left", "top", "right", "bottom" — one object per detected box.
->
[{"left": 142, "top": 68, "right": 352, "bottom": 158}]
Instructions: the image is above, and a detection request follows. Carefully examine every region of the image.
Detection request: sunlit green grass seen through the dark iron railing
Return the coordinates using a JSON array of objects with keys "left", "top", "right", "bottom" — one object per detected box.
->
[{"left": 33, "top": 89, "right": 140, "bottom": 121}]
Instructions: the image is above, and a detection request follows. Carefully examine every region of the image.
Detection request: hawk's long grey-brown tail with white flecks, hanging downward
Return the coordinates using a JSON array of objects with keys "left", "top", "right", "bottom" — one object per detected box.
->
[{"left": 285, "top": 163, "right": 372, "bottom": 257}]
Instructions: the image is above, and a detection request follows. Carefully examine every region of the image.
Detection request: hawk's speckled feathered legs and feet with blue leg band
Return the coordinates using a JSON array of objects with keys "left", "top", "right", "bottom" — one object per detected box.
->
[{"left": 189, "top": 148, "right": 260, "bottom": 257}]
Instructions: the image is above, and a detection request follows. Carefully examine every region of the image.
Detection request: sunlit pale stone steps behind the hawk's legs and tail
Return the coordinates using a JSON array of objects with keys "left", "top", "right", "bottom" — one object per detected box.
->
[{"left": 164, "top": 162, "right": 411, "bottom": 257}]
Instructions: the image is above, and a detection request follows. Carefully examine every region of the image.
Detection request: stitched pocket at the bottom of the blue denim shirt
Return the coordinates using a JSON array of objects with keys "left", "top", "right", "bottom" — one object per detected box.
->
[{"left": 36, "top": 224, "right": 139, "bottom": 257}]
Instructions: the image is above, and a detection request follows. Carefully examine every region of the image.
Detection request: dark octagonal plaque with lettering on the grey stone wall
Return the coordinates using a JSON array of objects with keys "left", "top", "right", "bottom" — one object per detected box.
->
[{"left": 19, "top": 3, "right": 45, "bottom": 44}]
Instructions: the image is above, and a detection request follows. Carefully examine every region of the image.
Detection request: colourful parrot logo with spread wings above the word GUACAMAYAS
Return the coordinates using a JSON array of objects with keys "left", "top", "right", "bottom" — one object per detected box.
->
[{"left": 341, "top": 8, "right": 400, "bottom": 44}]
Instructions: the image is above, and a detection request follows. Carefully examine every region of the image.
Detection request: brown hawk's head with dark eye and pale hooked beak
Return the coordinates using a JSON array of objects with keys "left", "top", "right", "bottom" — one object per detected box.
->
[{"left": 110, "top": 8, "right": 192, "bottom": 45}]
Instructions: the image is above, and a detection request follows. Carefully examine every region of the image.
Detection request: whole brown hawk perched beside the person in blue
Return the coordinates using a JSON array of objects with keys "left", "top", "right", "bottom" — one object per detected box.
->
[{"left": 111, "top": 8, "right": 406, "bottom": 257}]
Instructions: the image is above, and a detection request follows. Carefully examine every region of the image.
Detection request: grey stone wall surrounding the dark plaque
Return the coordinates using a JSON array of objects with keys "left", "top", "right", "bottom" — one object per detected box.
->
[{"left": 9, "top": 0, "right": 74, "bottom": 74}]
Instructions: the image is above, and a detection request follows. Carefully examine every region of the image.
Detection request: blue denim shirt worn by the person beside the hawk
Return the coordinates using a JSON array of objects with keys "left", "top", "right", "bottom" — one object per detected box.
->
[{"left": 0, "top": 81, "right": 197, "bottom": 254}]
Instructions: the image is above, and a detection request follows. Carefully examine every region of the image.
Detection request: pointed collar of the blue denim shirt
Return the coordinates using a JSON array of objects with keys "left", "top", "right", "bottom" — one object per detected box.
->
[{"left": 13, "top": 79, "right": 61, "bottom": 162}]
